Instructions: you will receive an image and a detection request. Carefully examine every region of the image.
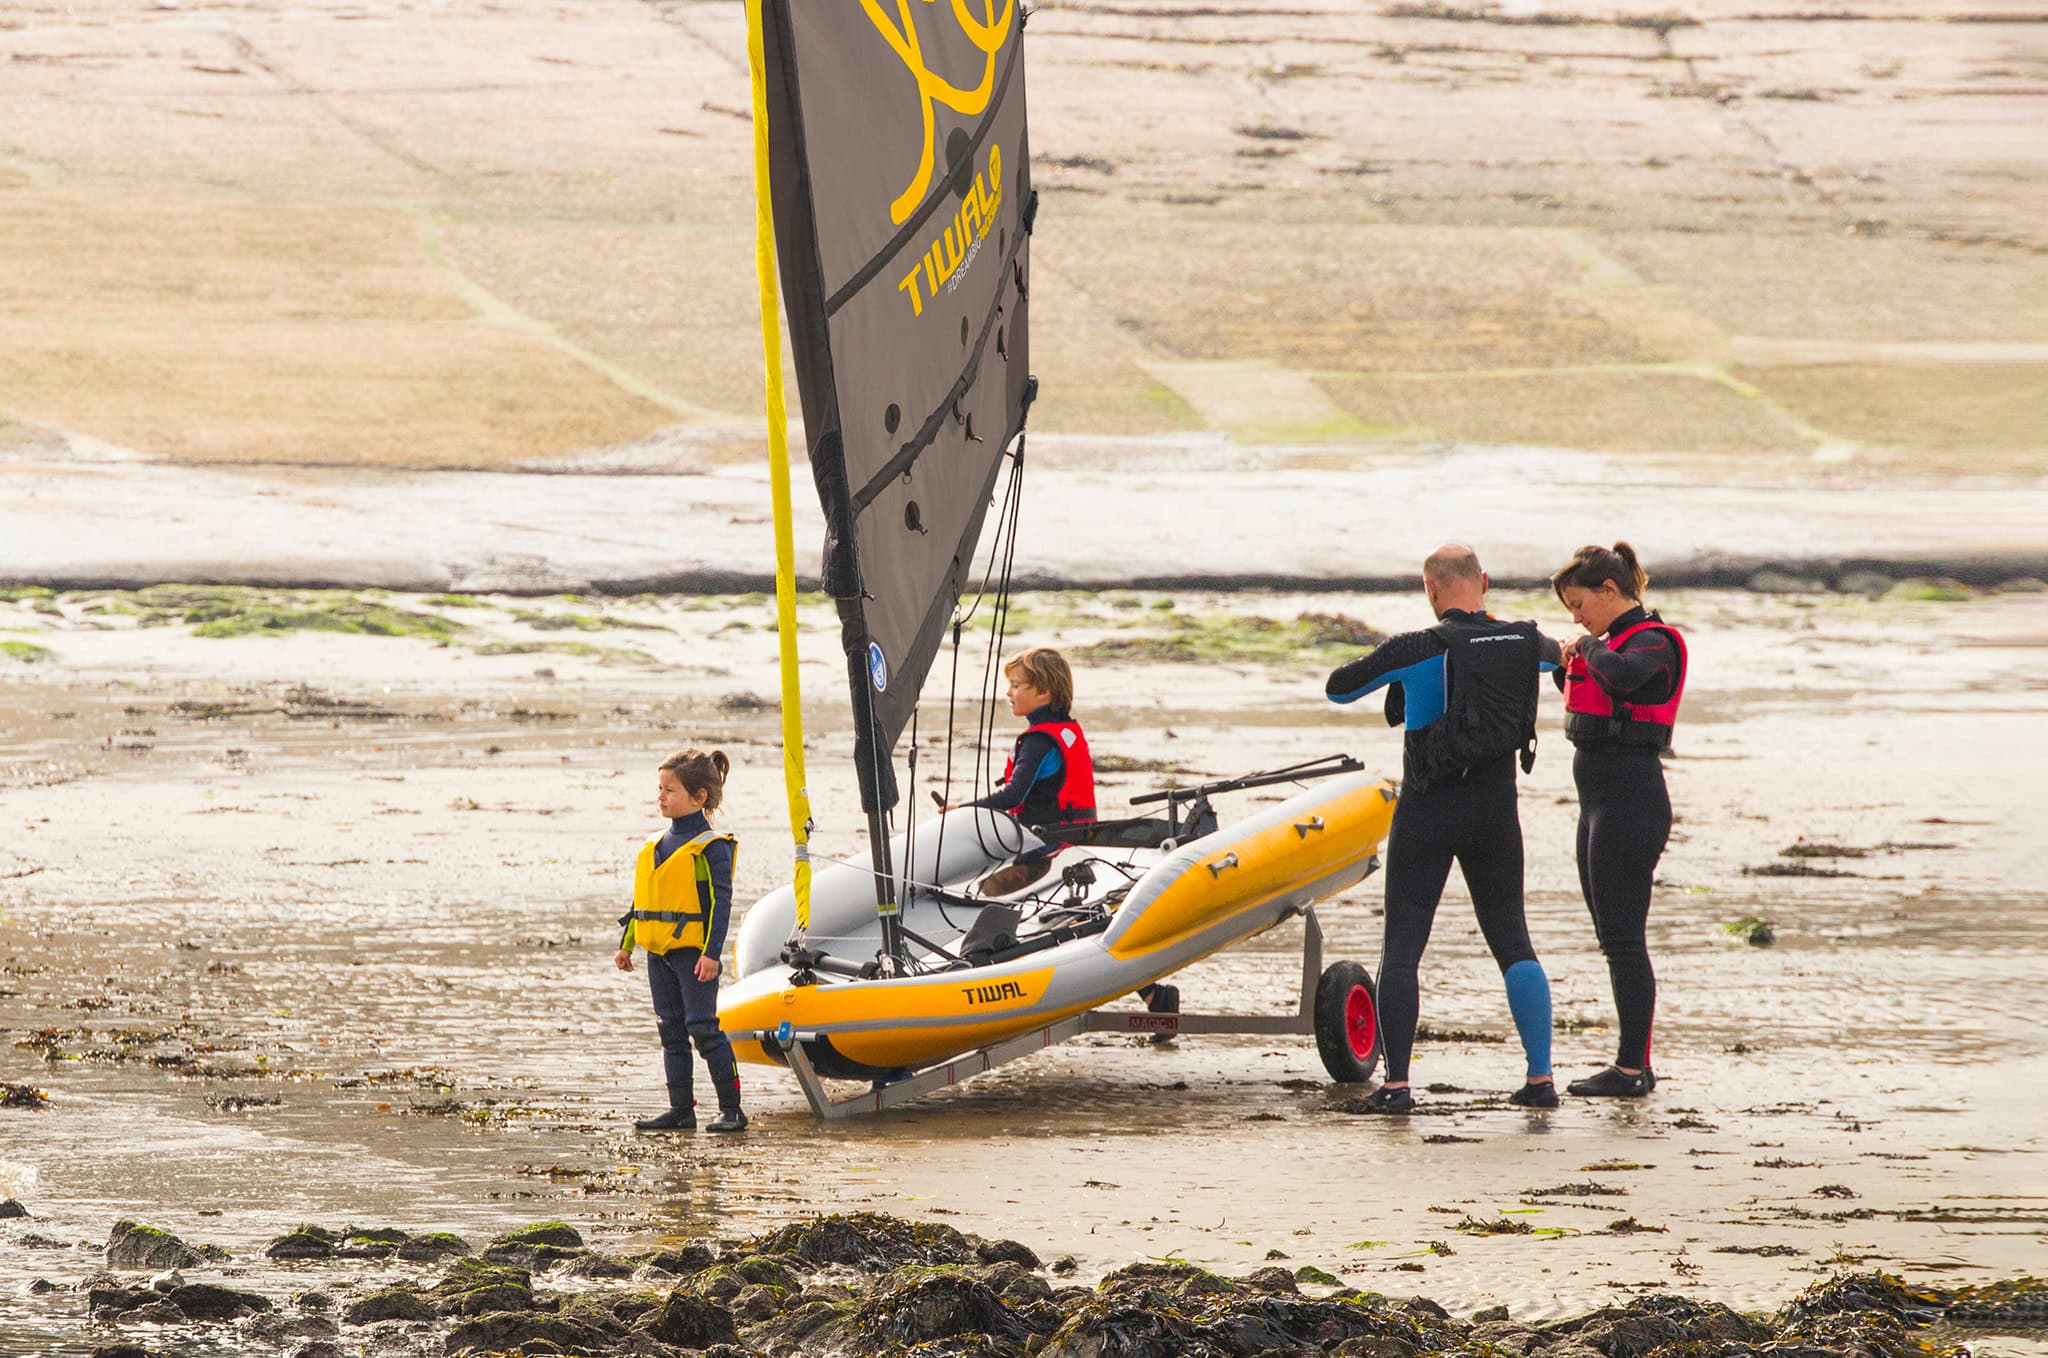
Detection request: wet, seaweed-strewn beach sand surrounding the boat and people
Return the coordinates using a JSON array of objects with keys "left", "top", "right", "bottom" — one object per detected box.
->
[{"left": 0, "top": 592, "right": 2048, "bottom": 1352}]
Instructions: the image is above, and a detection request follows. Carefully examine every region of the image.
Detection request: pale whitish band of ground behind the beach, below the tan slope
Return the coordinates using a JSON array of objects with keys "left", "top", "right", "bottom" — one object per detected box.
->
[{"left": 0, "top": 432, "right": 2048, "bottom": 594}]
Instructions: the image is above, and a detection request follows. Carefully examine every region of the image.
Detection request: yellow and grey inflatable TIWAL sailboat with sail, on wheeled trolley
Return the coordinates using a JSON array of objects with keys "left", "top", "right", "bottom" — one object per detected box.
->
[{"left": 719, "top": 0, "right": 1395, "bottom": 1116}]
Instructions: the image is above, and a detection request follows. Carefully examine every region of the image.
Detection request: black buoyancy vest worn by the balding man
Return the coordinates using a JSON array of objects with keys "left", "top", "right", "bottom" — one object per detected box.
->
[{"left": 1409, "top": 617, "right": 1542, "bottom": 791}]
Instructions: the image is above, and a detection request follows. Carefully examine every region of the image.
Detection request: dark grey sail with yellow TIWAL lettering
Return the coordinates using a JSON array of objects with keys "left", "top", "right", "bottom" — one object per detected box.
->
[{"left": 762, "top": 0, "right": 1036, "bottom": 813}]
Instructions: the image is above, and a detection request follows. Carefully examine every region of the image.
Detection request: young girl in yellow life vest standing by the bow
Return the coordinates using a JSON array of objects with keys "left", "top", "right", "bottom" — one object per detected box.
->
[{"left": 612, "top": 750, "right": 748, "bottom": 1133}]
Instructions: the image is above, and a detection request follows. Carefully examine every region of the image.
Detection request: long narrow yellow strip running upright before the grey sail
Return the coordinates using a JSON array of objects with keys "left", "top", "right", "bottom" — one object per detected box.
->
[{"left": 748, "top": 0, "right": 811, "bottom": 934}]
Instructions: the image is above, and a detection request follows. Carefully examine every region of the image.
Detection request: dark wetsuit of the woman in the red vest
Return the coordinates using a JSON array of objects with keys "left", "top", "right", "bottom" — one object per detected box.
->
[{"left": 1559, "top": 606, "right": 1683, "bottom": 1069}]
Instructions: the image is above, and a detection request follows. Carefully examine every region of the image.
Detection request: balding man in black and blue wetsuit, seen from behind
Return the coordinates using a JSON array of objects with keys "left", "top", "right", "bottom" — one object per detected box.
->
[{"left": 1325, "top": 543, "right": 1559, "bottom": 1112}]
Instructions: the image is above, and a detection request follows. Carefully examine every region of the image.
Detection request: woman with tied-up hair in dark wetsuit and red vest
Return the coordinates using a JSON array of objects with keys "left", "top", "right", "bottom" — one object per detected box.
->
[{"left": 1550, "top": 543, "right": 1686, "bottom": 1098}]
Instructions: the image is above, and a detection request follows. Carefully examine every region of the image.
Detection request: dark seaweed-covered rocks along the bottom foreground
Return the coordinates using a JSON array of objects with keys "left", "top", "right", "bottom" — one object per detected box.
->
[{"left": 19, "top": 1215, "right": 2048, "bottom": 1358}]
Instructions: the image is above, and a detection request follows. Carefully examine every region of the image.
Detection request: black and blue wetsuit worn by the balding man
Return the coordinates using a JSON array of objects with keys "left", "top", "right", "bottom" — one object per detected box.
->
[{"left": 1325, "top": 608, "right": 1559, "bottom": 1084}]
